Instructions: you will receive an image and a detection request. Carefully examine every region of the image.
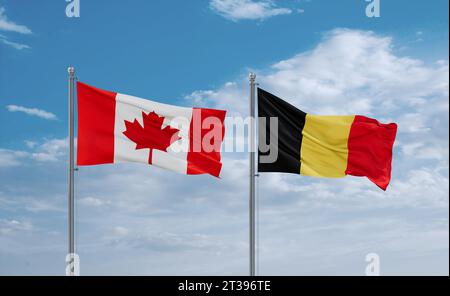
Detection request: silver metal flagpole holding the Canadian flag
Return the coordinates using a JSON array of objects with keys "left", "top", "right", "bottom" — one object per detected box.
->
[{"left": 67, "top": 67, "right": 75, "bottom": 276}]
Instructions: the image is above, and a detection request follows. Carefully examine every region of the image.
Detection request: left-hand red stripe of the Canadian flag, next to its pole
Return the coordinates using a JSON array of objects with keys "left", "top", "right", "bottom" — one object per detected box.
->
[{"left": 77, "top": 82, "right": 116, "bottom": 166}]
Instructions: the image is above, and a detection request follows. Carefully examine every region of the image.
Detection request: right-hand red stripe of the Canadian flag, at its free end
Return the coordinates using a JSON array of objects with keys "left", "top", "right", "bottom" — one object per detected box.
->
[{"left": 187, "top": 108, "right": 226, "bottom": 177}]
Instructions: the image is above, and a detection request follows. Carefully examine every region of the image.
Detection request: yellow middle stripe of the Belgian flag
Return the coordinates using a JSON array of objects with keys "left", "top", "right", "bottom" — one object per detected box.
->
[{"left": 300, "top": 114, "right": 355, "bottom": 178}]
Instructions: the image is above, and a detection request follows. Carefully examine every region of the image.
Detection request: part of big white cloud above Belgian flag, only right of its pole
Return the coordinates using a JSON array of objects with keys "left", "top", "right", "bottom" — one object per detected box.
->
[{"left": 259, "top": 29, "right": 448, "bottom": 115}]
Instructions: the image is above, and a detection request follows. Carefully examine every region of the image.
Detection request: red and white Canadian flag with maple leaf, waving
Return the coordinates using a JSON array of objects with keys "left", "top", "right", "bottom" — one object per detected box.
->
[{"left": 77, "top": 82, "right": 226, "bottom": 177}]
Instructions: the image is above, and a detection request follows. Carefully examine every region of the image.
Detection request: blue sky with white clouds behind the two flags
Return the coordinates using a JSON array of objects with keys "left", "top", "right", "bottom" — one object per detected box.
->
[{"left": 0, "top": 0, "right": 449, "bottom": 275}]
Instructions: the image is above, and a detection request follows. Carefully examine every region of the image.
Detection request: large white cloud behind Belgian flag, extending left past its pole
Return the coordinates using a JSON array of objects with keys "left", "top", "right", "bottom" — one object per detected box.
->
[{"left": 187, "top": 29, "right": 449, "bottom": 127}]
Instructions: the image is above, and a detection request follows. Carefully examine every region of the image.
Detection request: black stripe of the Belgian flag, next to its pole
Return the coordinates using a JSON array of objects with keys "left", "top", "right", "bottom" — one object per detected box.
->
[{"left": 258, "top": 88, "right": 306, "bottom": 174}]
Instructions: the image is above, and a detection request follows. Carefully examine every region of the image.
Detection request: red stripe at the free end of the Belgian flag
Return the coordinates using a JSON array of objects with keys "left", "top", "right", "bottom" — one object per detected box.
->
[{"left": 345, "top": 115, "right": 397, "bottom": 190}]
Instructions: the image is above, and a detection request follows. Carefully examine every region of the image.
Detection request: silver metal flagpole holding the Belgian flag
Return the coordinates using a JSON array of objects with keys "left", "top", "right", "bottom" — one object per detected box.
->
[{"left": 248, "top": 73, "right": 256, "bottom": 276}]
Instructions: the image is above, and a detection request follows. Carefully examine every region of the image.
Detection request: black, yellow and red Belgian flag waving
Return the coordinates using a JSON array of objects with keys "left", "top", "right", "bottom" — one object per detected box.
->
[{"left": 258, "top": 88, "right": 397, "bottom": 190}]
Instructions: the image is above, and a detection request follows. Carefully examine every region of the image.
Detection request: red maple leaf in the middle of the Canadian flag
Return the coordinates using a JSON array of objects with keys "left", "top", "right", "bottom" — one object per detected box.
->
[{"left": 123, "top": 111, "right": 181, "bottom": 164}]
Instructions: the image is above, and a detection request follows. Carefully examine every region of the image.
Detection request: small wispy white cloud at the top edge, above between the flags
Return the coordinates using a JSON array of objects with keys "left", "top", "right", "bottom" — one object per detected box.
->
[{"left": 209, "top": 0, "right": 292, "bottom": 21}]
